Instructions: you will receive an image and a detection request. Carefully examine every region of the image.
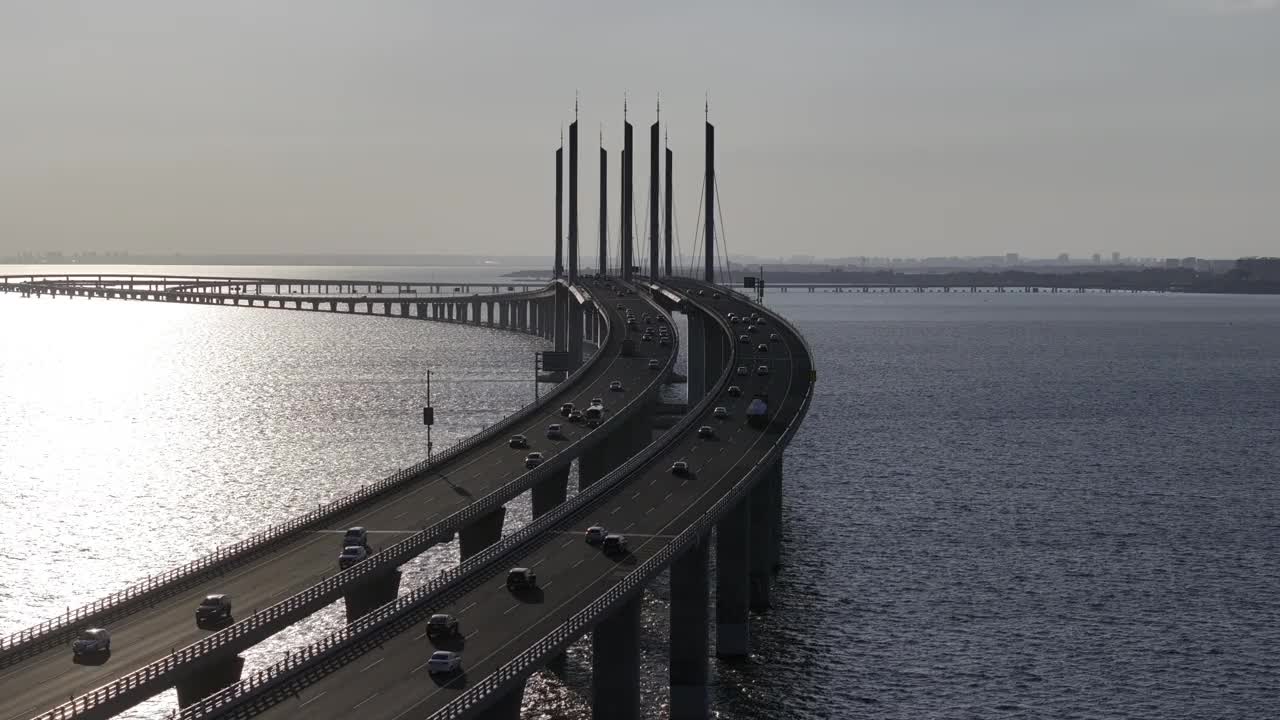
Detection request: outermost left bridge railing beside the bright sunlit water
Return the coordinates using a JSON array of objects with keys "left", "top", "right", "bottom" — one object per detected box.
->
[{"left": 0, "top": 280, "right": 596, "bottom": 662}]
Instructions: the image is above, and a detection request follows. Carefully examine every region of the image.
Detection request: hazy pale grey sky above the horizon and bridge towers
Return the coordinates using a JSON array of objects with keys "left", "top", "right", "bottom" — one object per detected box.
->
[{"left": 0, "top": 0, "right": 1280, "bottom": 258}]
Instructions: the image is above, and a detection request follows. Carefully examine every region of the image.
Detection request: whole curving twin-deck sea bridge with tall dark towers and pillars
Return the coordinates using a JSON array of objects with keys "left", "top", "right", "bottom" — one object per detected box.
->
[{"left": 0, "top": 109, "right": 815, "bottom": 719}]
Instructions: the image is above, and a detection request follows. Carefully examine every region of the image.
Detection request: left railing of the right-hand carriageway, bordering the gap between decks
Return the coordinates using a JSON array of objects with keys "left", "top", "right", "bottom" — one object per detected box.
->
[{"left": 172, "top": 288, "right": 701, "bottom": 720}]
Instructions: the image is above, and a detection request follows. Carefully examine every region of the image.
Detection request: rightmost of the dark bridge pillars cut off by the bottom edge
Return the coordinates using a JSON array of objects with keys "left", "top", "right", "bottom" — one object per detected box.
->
[{"left": 669, "top": 534, "right": 710, "bottom": 720}]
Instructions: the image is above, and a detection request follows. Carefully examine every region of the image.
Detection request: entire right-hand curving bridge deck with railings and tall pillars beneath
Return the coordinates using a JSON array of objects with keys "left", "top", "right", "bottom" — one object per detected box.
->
[{"left": 167, "top": 279, "right": 815, "bottom": 720}]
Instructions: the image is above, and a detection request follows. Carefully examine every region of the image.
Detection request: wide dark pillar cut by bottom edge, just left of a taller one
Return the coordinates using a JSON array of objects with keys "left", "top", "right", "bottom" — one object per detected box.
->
[{"left": 591, "top": 591, "right": 644, "bottom": 720}]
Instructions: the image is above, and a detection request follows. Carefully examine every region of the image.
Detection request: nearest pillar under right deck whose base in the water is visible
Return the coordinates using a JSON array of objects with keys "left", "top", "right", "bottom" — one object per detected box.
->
[{"left": 716, "top": 497, "right": 751, "bottom": 657}]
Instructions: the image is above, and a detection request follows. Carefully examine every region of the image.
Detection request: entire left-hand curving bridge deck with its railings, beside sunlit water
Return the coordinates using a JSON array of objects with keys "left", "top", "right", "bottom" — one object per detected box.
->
[{"left": 0, "top": 274, "right": 676, "bottom": 717}]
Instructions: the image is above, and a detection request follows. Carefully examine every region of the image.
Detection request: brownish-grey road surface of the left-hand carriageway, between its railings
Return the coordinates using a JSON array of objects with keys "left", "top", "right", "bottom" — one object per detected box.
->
[{"left": 0, "top": 287, "right": 672, "bottom": 720}]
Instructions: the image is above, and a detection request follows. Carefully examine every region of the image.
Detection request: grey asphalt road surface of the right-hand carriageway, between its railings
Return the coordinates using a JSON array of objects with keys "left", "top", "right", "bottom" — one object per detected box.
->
[{"left": 247, "top": 293, "right": 809, "bottom": 720}]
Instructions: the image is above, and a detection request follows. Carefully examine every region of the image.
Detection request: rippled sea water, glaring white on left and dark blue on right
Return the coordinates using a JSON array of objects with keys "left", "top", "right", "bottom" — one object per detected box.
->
[{"left": 0, "top": 272, "right": 1280, "bottom": 720}]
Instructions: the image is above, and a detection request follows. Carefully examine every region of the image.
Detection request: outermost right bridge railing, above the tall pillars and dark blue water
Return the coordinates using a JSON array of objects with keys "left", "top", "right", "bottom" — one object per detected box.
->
[{"left": 430, "top": 289, "right": 814, "bottom": 720}]
